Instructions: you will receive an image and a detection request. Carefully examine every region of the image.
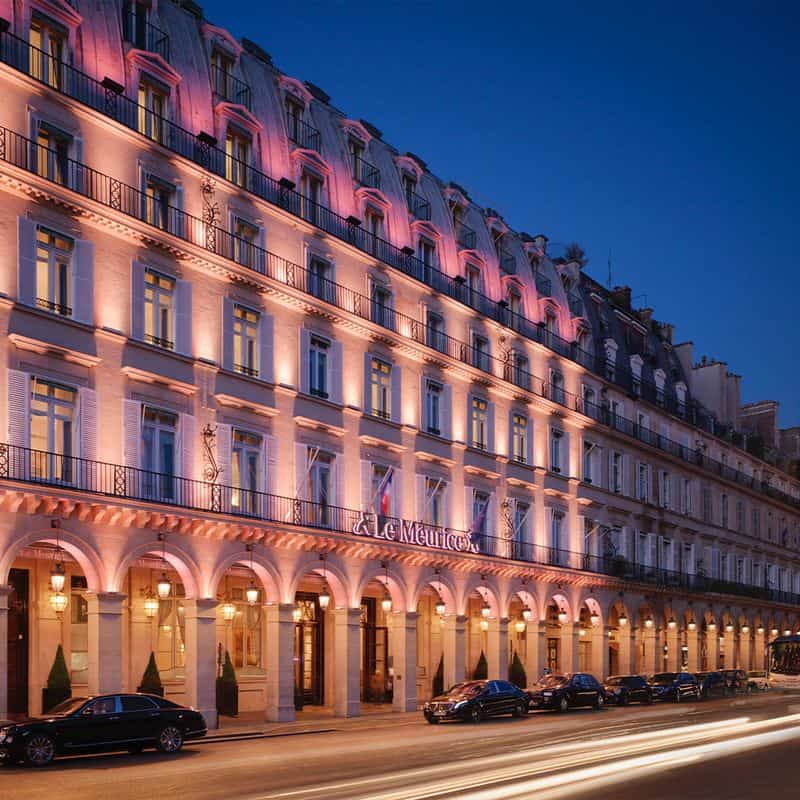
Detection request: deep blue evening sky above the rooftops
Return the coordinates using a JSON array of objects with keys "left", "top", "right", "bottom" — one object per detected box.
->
[{"left": 201, "top": 0, "right": 800, "bottom": 426}]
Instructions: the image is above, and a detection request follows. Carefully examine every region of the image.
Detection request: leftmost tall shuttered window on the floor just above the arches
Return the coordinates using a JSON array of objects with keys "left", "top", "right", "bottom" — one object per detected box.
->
[{"left": 30, "top": 378, "right": 78, "bottom": 482}]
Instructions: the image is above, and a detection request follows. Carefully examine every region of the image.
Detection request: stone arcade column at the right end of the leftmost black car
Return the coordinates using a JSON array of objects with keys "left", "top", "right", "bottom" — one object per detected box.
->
[{"left": 183, "top": 597, "right": 219, "bottom": 728}]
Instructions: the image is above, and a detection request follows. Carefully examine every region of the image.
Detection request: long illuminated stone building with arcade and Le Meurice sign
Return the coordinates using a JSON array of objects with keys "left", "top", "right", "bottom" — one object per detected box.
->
[{"left": 0, "top": 0, "right": 800, "bottom": 722}]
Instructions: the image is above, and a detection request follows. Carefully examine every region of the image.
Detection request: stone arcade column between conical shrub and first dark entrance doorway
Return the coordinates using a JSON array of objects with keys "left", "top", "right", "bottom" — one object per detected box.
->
[{"left": 264, "top": 603, "right": 295, "bottom": 722}]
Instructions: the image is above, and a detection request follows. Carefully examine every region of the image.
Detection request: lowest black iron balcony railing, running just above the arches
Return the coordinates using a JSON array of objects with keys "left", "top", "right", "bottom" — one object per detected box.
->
[{"left": 0, "top": 443, "right": 800, "bottom": 604}]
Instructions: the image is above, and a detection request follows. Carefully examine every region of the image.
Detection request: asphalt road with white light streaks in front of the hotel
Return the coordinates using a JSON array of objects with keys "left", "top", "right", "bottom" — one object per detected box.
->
[{"left": 0, "top": 694, "right": 800, "bottom": 800}]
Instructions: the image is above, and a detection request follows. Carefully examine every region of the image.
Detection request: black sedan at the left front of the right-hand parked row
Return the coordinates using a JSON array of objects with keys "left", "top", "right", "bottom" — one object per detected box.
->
[{"left": 423, "top": 681, "right": 528, "bottom": 725}]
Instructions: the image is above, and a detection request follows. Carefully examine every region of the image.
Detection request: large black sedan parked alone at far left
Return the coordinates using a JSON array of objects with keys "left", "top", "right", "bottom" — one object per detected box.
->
[{"left": 0, "top": 694, "right": 207, "bottom": 767}]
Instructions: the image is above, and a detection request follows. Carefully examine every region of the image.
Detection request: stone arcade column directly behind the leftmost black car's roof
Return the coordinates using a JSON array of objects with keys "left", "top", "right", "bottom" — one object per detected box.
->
[{"left": 86, "top": 592, "right": 126, "bottom": 694}]
